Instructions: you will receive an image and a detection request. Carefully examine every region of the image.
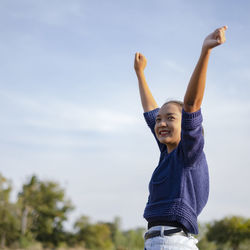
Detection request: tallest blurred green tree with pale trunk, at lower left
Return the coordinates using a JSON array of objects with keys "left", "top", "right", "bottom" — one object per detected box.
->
[{"left": 19, "top": 176, "right": 73, "bottom": 247}]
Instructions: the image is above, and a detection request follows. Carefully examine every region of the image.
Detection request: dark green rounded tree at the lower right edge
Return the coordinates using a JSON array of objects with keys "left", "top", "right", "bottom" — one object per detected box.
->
[{"left": 207, "top": 216, "right": 250, "bottom": 250}]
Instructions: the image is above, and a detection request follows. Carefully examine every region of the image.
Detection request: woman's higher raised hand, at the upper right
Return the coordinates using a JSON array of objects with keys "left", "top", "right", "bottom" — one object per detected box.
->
[{"left": 202, "top": 26, "right": 227, "bottom": 51}]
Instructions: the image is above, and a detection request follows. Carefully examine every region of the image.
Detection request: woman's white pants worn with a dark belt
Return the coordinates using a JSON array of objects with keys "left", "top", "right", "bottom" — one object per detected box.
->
[{"left": 144, "top": 226, "right": 198, "bottom": 250}]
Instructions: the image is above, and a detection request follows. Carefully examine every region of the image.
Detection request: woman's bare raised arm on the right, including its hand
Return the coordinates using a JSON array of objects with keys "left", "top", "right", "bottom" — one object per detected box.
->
[{"left": 184, "top": 26, "right": 227, "bottom": 113}]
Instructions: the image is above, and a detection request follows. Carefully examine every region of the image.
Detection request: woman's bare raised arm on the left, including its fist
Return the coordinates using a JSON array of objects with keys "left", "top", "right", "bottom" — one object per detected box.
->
[{"left": 134, "top": 52, "right": 158, "bottom": 112}]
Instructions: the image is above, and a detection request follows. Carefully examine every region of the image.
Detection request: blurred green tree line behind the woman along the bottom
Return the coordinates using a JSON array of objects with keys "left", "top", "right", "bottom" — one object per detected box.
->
[{"left": 0, "top": 174, "right": 250, "bottom": 250}]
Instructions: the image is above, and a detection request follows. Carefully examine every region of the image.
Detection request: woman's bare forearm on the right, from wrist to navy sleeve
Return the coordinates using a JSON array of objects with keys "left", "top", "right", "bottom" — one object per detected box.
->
[{"left": 184, "top": 50, "right": 211, "bottom": 112}]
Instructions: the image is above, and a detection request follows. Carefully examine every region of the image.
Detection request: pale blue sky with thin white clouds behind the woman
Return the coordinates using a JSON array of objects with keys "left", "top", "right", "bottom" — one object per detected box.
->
[{"left": 0, "top": 0, "right": 250, "bottom": 228}]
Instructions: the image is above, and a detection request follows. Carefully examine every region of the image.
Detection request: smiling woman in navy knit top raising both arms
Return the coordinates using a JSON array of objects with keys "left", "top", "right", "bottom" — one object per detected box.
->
[{"left": 134, "top": 26, "right": 227, "bottom": 250}]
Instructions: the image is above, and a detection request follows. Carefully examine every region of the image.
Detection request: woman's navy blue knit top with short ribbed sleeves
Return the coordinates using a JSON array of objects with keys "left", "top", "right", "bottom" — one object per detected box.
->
[{"left": 144, "top": 108, "right": 209, "bottom": 234}]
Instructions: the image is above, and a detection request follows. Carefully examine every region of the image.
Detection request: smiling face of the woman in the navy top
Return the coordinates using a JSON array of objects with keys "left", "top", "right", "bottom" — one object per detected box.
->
[{"left": 155, "top": 102, "right": 181, "bottom": 153}]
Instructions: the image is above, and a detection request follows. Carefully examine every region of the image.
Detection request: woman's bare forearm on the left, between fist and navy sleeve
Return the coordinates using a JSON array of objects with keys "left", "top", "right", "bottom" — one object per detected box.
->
[{"left": 136, "top": 71, "right": 158, "bottom": 112}]
